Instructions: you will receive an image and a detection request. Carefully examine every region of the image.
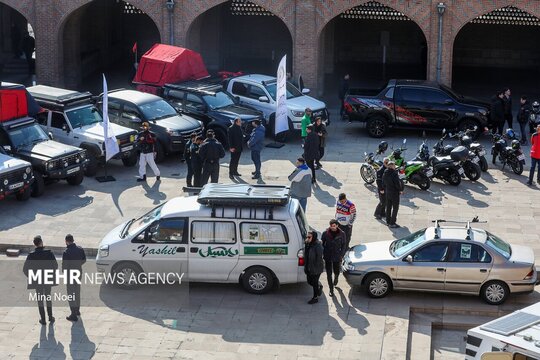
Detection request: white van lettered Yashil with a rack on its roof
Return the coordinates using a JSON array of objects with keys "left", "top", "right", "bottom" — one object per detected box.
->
[{"left": 96, "top": 184, "right": 309, "bottom": 294}]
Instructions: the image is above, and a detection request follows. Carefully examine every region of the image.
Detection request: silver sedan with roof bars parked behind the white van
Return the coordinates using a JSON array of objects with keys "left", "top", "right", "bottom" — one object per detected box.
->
[{"left": 343, "top": 226, "right": 540, "bottom": 305}]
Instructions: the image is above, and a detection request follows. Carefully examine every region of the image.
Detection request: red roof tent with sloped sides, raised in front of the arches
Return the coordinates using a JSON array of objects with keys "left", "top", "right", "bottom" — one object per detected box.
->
[{"left": 133, "top": 44, "right": 208, "bottom": 92}]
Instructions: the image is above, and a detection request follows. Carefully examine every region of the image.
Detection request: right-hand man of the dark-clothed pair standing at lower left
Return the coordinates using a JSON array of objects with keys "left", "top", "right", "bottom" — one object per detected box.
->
[{"left": 62, "top": 234, "right": 86, "bottom": 321}]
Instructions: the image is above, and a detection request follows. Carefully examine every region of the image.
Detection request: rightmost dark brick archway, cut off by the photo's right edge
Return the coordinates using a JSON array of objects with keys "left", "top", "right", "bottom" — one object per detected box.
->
[{"left": 452, "top": 6, "right": 540, "bottom": 101}]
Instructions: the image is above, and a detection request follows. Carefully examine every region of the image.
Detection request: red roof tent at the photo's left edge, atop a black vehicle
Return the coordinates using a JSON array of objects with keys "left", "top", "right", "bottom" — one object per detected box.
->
[{"left": 0, "top": 83, "right": 41, "bottom": 122}]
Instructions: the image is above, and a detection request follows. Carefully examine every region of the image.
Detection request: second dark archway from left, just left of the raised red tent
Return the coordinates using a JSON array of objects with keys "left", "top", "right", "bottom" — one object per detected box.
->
[{"left": 61, "top": 0, "right": 160, "bottom": 92}]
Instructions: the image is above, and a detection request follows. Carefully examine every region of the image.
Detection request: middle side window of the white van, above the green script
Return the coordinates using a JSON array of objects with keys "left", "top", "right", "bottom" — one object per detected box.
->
[{"left": 191, "top": 221, "right": 236, "bottom": 244}]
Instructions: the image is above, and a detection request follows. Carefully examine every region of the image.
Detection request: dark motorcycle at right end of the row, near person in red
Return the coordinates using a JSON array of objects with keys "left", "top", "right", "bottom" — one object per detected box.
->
[{"left": 489, "top": 129, "right": 525, "bottom": 175}]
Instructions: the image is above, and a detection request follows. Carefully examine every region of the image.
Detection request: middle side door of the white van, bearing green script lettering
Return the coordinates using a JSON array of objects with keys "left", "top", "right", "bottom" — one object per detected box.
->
[{"left": 188, "top": 220, "right": 239, "bottom": 282}]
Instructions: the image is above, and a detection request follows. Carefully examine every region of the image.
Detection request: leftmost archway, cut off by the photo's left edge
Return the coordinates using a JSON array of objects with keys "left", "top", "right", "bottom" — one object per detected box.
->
[{"left": 0, "top": 3, "right": 35, "bottom": 85}]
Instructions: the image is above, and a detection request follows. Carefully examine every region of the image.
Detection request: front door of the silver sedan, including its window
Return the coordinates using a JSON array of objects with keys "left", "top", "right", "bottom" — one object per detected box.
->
[{"left": 395, "top": 241, "right": 449, "bottom": 290}]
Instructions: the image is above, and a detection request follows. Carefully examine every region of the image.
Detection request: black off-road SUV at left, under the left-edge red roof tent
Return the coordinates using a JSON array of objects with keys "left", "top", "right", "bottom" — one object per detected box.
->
[{"left": 0, "top": 117, "right": 87, "bottom": 197}]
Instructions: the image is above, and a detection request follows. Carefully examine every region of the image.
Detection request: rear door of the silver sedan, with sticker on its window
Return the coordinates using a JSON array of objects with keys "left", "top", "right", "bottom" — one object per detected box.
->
[{"left": 444, "top": 242, "right": 493, "bottom": 293}]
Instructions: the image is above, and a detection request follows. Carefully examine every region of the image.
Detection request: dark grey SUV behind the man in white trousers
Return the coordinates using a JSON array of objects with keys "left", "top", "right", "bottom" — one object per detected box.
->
[{"left": 108, "top": 90, "right": 203, "bottom": 163}]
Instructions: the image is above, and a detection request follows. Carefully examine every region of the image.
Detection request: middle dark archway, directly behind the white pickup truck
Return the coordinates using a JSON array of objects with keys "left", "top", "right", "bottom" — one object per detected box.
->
[{"left": 187, "top": 0, "right": 292, "bottom": 75}]
